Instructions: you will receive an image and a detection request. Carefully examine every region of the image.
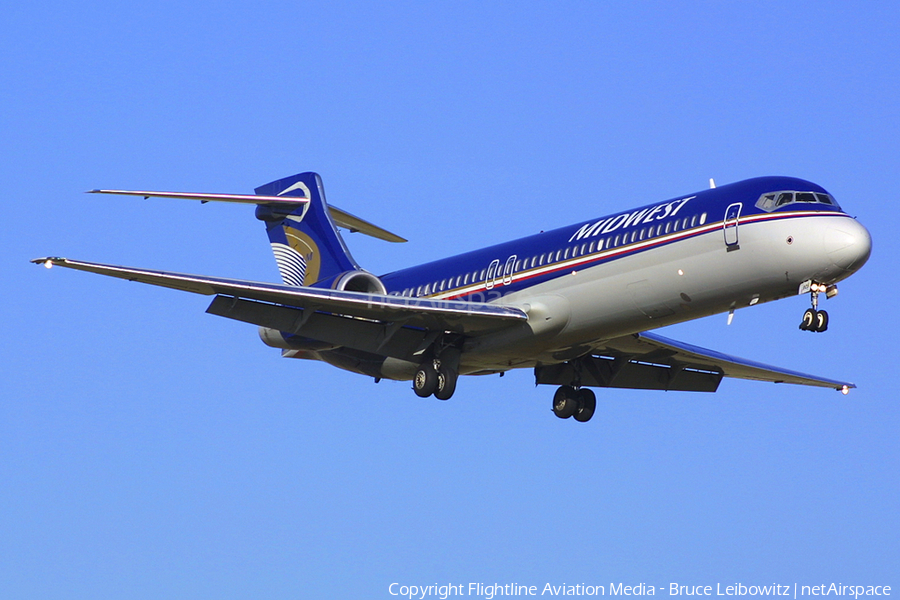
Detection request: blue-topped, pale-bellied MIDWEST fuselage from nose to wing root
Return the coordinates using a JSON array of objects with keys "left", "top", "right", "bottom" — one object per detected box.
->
[{"left": 381, "top": 177, "right": 871, "bottom": 370}]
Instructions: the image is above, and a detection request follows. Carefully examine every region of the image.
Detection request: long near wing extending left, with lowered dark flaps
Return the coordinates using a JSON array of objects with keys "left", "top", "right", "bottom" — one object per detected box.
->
[{"left": 31, "top": 257, "right": 528, "bottom": 358}]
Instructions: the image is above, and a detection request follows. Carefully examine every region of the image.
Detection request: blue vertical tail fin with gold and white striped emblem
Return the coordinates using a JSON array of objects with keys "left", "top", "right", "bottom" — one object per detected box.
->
[{"left": 255, "top": 173, "right": 359, "bottom": 286}]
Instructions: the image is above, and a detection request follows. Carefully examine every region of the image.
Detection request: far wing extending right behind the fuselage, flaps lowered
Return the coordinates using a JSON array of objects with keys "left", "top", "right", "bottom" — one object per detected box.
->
[{"left": 535, "top": 332, "right": 856, "bottom": 392}]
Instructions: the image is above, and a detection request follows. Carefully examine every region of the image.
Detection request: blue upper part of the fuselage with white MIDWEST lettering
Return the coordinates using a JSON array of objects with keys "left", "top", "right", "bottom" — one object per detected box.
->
[{"left": 372, "top": 177, "right": 843, "bottom": 301}]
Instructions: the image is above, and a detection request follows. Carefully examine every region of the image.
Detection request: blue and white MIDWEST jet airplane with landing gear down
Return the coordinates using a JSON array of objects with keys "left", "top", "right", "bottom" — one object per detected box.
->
[{"left": 32, "top": 172, "right": 872, "bottom": 422}]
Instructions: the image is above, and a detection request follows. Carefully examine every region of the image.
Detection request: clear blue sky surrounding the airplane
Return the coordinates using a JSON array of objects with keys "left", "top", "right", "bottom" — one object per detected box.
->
[{"left": 0, "top": 1, "right": 900, "bottom": 599}]
